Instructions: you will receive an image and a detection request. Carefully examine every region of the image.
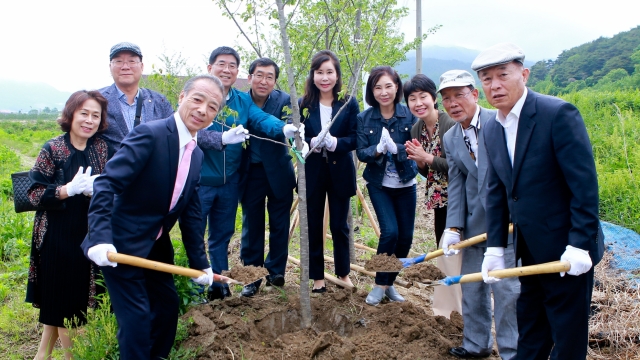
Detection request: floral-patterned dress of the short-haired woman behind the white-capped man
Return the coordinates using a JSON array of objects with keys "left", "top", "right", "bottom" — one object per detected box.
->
[{"left": 420, "top": 120, "right": 447, "bottom": 210}]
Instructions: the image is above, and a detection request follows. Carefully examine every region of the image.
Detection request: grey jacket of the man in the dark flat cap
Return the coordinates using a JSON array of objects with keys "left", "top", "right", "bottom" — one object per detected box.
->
[{"left": 100, "top": 83, "right": 173, "bottom": 150}]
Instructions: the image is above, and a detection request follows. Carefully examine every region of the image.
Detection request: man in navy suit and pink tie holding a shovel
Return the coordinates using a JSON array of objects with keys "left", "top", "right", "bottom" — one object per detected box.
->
[{"left": 82, "top": 75, "right": 244, "bottom": 360}]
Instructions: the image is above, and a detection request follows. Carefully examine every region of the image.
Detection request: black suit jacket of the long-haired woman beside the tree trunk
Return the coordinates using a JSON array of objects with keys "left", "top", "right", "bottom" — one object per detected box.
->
[{"left": 298, "top": 96, "right": 360, "bottom": 197}]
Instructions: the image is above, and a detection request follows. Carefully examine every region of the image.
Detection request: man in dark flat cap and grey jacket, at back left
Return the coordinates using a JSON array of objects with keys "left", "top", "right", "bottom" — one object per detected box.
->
[{"left": 100, "top": 42, "right": 173, "bottom": 150}]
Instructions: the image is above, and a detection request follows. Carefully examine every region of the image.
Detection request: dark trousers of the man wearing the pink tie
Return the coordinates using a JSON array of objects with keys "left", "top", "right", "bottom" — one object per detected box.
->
[{"left": 101, "top": 233, "right": 179, "bottom": 360}]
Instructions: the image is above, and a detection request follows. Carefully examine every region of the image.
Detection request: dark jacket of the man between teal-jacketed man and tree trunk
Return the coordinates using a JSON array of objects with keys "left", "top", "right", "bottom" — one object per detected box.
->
[{"left": 240, "top": 90, "right": 296, "bottom": 199}]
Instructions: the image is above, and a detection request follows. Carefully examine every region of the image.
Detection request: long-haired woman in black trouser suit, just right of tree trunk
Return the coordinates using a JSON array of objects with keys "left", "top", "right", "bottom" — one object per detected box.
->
[{"left": 300, "top": 50, "right": 360, "bottom": 293}]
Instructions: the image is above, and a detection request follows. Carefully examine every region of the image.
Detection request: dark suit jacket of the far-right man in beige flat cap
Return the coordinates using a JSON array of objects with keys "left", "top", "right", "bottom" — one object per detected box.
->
[{"left": 484, "top": 90, "right": 604, "bottom": 265}]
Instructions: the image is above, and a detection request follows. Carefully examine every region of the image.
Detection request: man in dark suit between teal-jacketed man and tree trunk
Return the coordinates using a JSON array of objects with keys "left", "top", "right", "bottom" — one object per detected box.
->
[{"left": 240, "top": 58, "right": 296, "bottom": 296}]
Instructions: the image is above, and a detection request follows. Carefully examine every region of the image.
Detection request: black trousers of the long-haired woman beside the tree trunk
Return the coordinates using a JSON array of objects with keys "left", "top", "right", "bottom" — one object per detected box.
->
[{"left": 307, "top": 165, "right": 350, "bottom": 280}]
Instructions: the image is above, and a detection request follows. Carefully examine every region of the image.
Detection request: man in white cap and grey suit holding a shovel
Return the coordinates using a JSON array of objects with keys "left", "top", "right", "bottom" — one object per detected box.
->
[{"left": 438, "top": 70, "right": 520, "bottom": 360}]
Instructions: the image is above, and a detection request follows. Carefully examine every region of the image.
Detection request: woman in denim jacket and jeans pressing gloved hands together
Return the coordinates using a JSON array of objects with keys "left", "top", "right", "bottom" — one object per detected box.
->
[{"left": 357, "top": 66, "right": 418, "bottom": 306}]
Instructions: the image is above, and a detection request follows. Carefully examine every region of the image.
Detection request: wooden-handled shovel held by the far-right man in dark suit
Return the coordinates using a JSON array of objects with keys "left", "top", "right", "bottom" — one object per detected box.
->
[{"left": 425, "top": 261, "right": 571, "bottom": 286}]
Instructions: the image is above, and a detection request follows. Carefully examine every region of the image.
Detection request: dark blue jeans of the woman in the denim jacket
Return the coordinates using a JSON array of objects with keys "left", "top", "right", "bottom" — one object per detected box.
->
[{"left": 367, "top": 184, "right": 417, "bottom": 286}]
